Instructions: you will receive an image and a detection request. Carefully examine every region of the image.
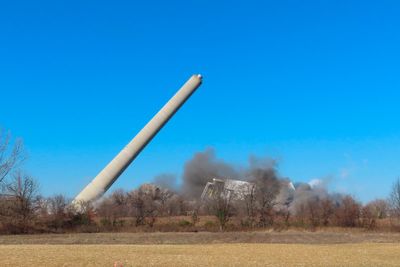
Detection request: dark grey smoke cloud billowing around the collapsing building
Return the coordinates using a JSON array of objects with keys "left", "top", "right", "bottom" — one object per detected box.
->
[{"left": 154, "top": 148, "right": 340, "bottom": 213}]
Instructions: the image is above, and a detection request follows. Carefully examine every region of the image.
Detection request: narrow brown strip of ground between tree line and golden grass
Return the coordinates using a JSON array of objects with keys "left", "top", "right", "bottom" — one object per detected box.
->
[{"left": 0, "top": 231, "right": 400, "bottom": 245}]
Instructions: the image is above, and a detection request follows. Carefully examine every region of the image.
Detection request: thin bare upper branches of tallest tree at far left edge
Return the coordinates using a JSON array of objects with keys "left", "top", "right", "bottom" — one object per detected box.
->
[{"left": 0, "top": 129, "right": 25, "bottom": 186}]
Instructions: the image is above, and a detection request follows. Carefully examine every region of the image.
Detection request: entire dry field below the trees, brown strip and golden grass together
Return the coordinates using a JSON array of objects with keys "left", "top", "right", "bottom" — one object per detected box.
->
[{"left": 0, "top": 231, "right": 400, "bottom": 266}]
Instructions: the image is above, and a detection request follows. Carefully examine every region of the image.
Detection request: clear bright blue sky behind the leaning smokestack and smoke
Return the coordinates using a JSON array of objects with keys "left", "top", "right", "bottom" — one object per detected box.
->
[{"left": 0, "top": 0, "right": 400, "bottom": 201}]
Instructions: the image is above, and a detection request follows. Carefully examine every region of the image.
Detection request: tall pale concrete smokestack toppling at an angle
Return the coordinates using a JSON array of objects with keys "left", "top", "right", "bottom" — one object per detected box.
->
[{"left": 74, "top": 75, "right": 202, "bottom": 203}]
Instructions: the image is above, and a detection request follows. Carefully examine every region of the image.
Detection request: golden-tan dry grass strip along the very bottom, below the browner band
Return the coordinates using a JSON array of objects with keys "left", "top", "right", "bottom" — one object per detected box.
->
[{"left": 0, "top": 243, "right": 400, "bottom": 266}]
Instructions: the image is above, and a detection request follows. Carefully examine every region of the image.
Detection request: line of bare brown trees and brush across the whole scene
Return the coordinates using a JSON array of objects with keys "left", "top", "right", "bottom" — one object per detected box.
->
[{"left": 0, "top": 131, "right": 400, "bottom": 234}]
